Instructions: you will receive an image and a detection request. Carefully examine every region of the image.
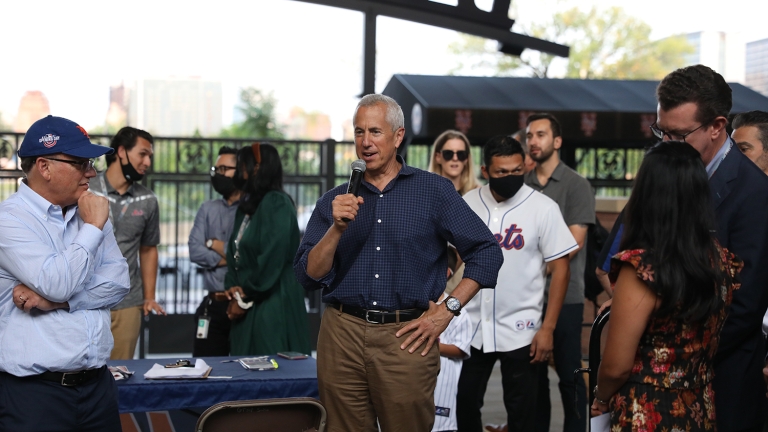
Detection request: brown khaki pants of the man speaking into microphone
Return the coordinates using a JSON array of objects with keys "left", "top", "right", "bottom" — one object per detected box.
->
[{"left": 317, "top": 308, "right": 440, "bottom": 432}]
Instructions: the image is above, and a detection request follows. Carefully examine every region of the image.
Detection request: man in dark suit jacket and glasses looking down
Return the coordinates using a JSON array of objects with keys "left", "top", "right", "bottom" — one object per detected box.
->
[{"left": 652, "top": 65, "right": 768, "bottom": 432}]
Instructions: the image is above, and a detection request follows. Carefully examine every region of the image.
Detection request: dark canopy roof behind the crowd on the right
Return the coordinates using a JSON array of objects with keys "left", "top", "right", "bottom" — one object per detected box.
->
[{"left": 383, "top": 75, "right": 768, "bottom": 145}]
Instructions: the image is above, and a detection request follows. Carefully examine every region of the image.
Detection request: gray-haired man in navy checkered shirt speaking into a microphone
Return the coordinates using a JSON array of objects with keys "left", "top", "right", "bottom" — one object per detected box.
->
[{"left": 294, "top": 95, "right": 503, "bottom": 432}]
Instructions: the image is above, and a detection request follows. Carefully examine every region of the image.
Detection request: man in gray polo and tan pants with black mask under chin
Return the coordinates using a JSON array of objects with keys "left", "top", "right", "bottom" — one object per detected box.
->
[{"left": 91, "top": 126, "right": 165, "bottom": 360}]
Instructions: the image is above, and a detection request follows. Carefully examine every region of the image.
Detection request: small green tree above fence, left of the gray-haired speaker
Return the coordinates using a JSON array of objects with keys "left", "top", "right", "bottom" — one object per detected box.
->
[{"left": 219, "top": 87, "right": 283, "bottom": 138}]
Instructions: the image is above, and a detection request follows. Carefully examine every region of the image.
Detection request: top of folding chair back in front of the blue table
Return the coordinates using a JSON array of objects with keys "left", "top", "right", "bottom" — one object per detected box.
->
[{"left": 195, "top": 398, "right": 326, "bottom": 432}]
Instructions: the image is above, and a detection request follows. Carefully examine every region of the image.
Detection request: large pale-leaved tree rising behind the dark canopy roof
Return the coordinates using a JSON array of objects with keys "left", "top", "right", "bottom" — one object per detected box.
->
[{"left": 449, "top": 7, "right": 693, "bottom": 79}]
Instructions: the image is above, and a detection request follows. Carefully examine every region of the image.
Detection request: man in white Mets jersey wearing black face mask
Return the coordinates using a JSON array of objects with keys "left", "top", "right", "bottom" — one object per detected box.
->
[{"left": 457, "top": 136, "right": 579, "bottom": 432}]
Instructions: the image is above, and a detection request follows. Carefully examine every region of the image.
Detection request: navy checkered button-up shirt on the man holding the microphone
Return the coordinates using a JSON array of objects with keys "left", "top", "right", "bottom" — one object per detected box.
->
[{"left": 294, "top": 156, "right": 503, "bottom": 311}]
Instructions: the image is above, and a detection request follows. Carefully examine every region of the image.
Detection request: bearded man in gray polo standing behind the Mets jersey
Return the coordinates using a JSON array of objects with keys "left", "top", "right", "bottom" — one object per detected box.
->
[{"left": 525, "top": 114, "right": 595, "bottom": 432}]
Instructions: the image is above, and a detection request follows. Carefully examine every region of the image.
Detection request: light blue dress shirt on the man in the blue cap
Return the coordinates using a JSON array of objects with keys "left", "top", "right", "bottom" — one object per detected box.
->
[{"left": 0, "top": 183, "right": 130, "bottom": 376}]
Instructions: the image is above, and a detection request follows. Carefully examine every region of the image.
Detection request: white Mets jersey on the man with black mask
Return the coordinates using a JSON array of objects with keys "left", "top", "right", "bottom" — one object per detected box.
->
[{"left": 464, "top": 185, "right": 578, "bottom": 352}]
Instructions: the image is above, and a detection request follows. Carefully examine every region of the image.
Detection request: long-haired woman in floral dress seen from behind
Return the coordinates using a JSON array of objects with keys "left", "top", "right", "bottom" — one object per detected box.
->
[{"left": 592, "top": 141, "right": 741, "bottom": 432}]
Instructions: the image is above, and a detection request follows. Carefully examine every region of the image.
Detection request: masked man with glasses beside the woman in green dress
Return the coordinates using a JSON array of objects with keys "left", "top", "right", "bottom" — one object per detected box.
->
[{"left": 189, "top": 147, "right": 240, "bottom": 357}]
